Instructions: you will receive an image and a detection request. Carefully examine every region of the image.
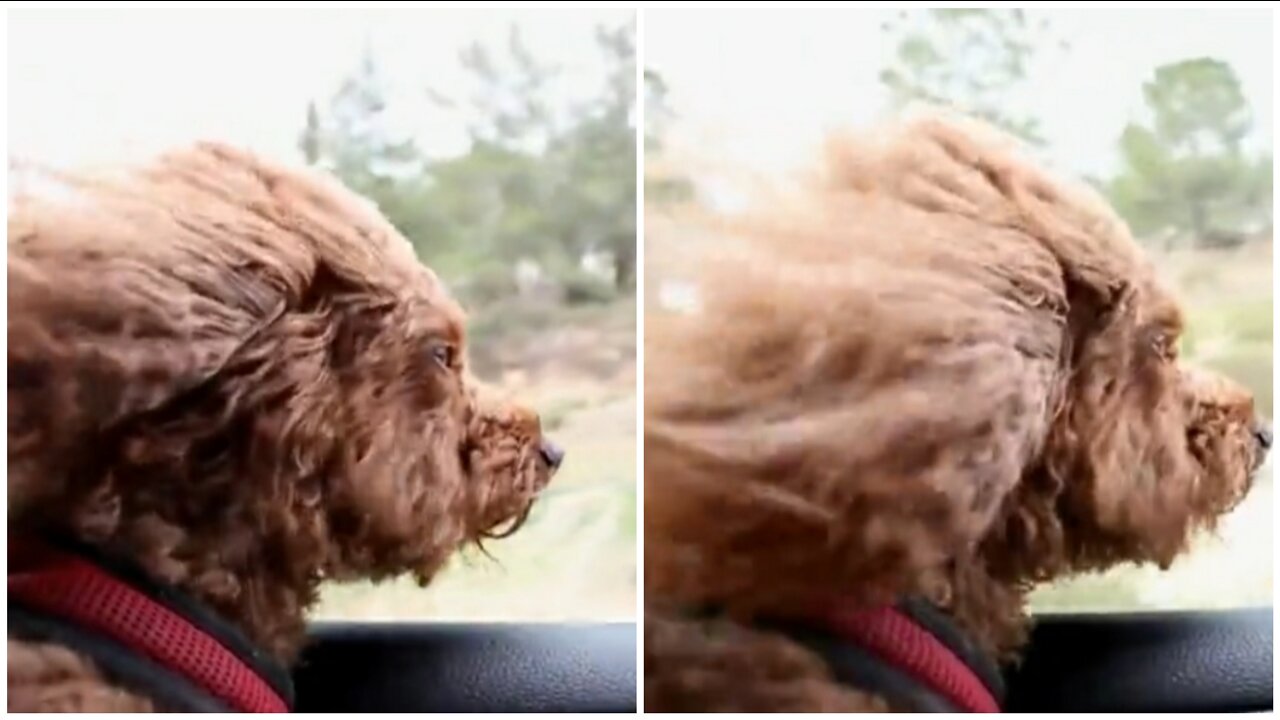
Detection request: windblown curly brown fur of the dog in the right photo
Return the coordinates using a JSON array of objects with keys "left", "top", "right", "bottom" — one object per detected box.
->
[{"left": 644, "top": 118, "right": 1263, "bottom": 711}]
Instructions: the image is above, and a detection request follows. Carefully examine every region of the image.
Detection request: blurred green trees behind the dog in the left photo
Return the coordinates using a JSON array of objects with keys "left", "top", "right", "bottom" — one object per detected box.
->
[{"left": 298, "top": 23, "right": 636, "bottom": 313}]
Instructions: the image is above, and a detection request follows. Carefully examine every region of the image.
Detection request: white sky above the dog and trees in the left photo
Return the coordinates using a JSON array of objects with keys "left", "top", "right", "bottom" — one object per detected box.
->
[{"left": 8, "top": 8, "right": 632, "bottom": 163}]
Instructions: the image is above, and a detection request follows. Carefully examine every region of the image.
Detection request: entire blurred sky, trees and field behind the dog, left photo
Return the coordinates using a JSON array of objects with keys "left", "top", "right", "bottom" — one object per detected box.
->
[{"left": 8, "top": 9, "right": 636, "bottom": 620}]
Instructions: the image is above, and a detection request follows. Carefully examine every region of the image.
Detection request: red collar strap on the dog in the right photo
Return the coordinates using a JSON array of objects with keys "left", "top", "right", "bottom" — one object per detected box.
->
[{"left": 818, "top": 600, "right": 1004, "bottom": 712}]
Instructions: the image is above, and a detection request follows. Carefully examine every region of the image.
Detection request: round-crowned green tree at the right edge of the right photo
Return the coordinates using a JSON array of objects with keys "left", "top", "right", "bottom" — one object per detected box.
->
[{"left": 1106, "top": 58, "right": 1271, "bottom": 246}]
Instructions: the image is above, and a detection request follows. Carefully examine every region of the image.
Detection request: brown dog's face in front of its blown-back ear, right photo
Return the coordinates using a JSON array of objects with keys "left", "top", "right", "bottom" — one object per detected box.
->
[{"left": 983, "top": 257, "right": 1271, "bottom": 582}]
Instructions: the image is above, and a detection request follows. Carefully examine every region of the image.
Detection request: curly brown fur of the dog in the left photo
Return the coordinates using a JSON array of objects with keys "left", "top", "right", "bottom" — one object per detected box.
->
[{"left": 8, "top": 145, "right": 553, "bottom": 710}]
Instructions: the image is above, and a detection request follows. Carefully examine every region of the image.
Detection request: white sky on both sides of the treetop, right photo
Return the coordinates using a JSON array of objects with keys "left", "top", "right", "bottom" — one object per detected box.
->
[{"left": 644, "top": 9, "right": 1274, "bottom": 173}]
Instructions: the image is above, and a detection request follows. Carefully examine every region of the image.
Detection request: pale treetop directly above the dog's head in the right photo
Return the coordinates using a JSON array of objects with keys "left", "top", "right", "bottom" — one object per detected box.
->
[{"left": 881, "top": 9, "right": 1066, "bottom": 145}]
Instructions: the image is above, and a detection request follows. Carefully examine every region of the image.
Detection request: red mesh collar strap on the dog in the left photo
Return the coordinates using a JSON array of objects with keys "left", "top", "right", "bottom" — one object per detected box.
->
[{"left": 9, "top": 537, "right": 292, "bottom": 712}]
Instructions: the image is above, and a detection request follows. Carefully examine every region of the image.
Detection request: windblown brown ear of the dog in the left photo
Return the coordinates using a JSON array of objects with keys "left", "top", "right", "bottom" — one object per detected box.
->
[{"left": 8, "top": 152, "right": 314, "bottom": 518}]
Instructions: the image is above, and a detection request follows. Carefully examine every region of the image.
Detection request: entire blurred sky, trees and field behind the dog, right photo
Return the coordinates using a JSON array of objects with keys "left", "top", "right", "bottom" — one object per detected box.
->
[{"left": 643, "top": 9, "right": 1274, "bottom": 611}]
